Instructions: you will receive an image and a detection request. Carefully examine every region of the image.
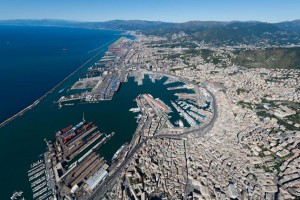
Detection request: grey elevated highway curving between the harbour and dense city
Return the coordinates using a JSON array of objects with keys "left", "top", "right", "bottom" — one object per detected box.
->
[{"left": 88, "top": 83, "right": 218, "bottom": 200}]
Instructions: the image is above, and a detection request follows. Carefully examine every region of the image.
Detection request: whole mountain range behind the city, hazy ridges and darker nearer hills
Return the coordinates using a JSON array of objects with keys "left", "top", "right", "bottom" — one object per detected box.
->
[{"left": 0, "top": 19, "right": 300, "bottom": 45}]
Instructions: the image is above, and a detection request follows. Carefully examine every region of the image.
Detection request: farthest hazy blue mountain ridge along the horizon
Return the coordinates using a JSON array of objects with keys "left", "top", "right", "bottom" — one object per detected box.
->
[{"left": 0, "top": 19, "right": 300, "bottom": 33}]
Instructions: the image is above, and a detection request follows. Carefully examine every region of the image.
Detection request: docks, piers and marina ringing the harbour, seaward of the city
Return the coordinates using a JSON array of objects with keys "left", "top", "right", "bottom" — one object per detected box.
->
[{"left": 24, "top": 37, "right": 216, "bottom": 199}]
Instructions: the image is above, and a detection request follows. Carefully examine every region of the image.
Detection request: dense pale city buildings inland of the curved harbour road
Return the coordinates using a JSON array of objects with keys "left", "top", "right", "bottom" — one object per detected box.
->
[{"left": 103, "top": 32, "right": 300, "bottom": 199}]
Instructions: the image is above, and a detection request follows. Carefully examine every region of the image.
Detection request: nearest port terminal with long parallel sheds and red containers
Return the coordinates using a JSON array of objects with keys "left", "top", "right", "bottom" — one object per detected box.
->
[{"left": 28, "top": 113, "right": 130, "bottom": 199}]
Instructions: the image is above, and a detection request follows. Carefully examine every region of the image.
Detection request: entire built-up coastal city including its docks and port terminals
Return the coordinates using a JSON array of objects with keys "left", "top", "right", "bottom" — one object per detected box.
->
[{"left": 18, "top": 32, "right": 300, "bottom": 200}]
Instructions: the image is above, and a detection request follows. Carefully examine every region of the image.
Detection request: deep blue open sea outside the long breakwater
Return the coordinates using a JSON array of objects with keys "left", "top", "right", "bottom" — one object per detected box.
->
[{"left": 0, "top": 26, "right": 120, "bottom": 122}]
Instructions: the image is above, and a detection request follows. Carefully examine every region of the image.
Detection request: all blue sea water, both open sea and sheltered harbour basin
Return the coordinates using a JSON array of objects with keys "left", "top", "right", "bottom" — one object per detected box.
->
[{"left": 0, "top": 26, "right": 191, "bottom": 199}]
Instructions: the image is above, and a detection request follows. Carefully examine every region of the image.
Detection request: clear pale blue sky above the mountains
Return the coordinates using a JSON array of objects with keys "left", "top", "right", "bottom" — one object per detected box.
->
[{"left": 0, "top": 0, "right": 300, "bottom": 22}]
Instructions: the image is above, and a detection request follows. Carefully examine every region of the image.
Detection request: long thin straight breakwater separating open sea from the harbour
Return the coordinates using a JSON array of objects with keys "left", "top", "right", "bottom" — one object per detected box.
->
[{"left": 0, "top": 38, "right": 119, "bottom": 128}]
